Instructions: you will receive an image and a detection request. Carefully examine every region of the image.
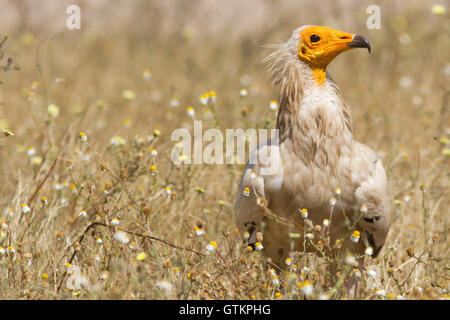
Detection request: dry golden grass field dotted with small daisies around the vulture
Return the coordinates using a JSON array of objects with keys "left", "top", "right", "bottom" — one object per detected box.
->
[{"left": 0, "top": 0, "right": 450, "bottom": 299}]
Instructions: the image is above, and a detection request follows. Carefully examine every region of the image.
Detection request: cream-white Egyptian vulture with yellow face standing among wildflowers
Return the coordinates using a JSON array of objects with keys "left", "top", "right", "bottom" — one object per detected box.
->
[{"left": 235, "top": 26, "right": 390, "bottom": 296}]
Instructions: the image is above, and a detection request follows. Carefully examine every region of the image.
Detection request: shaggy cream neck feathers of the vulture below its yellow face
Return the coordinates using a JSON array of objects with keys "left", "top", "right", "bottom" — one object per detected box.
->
[{"left": 266, "top": 45, "right": 353, "bottom": 165}]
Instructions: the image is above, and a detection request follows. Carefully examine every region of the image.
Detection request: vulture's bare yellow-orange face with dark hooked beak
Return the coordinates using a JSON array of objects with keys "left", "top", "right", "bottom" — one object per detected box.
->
[{"left": 298, "top": 26, "right": 370, "bottom": 74}]
